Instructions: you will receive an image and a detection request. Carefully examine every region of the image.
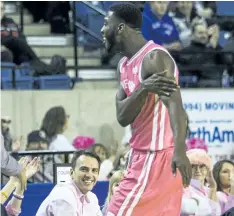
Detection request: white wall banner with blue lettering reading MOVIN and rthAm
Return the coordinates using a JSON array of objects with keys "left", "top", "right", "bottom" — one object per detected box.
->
[{"left": 182, "top": 89, "right": 234, "bottom": 162}]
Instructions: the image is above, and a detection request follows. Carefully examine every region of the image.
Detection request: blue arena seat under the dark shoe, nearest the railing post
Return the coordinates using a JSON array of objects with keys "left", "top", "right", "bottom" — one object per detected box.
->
[{"left": 36, "top": 74, "right": 72, "bottom": 90}]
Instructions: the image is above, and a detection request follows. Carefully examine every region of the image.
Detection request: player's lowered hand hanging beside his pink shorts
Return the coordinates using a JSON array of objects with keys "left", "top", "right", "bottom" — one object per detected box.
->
[{"left": 171, "top": 151, "right": 192, "bottom": 187}]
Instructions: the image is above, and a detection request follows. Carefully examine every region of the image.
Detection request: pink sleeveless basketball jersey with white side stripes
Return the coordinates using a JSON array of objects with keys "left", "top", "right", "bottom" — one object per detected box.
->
[{"left": 120, "top": 41, "right": 178, "bottom": 151}]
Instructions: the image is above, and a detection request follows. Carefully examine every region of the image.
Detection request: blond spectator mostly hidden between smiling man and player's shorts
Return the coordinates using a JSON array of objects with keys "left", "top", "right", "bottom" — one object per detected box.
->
[{"left": 102, "top": 170, "right": 124, "bottom": 215}]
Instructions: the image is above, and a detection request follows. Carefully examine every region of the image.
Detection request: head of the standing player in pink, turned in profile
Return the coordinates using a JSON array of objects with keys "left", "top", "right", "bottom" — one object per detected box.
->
[{"left": 101, "top": 3, "right": 142, "bottom": 52}]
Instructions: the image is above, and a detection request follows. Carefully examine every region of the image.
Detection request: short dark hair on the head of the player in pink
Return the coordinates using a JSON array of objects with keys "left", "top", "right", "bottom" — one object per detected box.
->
[{"left": 110, "top": 3, "right": 142, "bottom": 29}]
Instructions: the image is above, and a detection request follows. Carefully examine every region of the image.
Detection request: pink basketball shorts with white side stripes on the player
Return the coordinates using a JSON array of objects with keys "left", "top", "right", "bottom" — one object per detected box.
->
[{"left": 106, "top": 148, "right": 183, "bottom": 216}]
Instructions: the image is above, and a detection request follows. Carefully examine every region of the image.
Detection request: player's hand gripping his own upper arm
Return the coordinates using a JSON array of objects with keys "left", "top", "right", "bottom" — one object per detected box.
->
[{"left": 142, "top": 71, "right": 179, "bottom": 97}]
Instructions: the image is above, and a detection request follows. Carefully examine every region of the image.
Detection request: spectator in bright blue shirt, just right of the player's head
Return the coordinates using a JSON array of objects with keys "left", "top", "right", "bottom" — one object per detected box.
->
[{"left": 142, "top": 1, "right": 181, "bottom": 50}]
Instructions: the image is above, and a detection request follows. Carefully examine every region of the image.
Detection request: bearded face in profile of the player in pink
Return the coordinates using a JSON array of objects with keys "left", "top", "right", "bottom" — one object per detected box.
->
[{"left": 101, "top": 11, "right": 121, "bottom": 52}]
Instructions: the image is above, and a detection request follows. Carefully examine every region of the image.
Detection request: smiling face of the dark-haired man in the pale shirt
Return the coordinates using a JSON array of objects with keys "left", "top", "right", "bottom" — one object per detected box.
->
[{"left": 71, "top": 155, "right": 99, "bottom": 194}]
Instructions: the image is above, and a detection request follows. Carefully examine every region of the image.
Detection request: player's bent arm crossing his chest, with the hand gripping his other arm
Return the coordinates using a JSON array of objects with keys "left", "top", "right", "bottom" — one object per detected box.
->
[{"left": 116, "top": 60, "right": 177, "bottom": 127}]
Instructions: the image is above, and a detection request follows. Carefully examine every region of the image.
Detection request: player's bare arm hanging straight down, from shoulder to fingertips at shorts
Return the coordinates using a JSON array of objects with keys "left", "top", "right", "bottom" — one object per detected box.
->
[{"left": 141, "top": 50, "right": 191, "bottom": 185}]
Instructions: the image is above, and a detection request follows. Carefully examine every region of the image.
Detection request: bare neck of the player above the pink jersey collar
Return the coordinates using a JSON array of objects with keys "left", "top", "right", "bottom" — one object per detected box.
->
[{"left": 123, "top": 35, "right": 147, "bottom": 58}]
